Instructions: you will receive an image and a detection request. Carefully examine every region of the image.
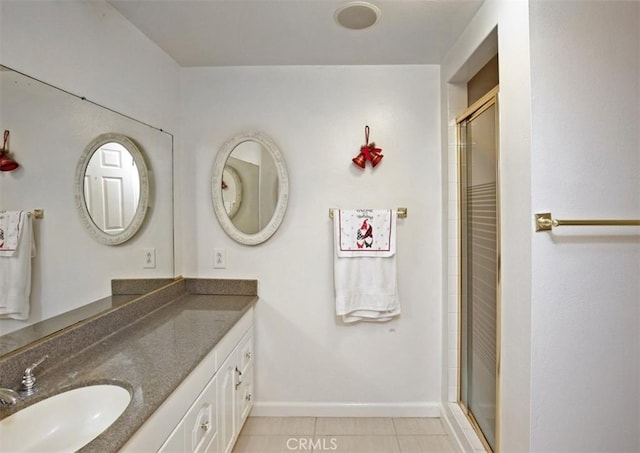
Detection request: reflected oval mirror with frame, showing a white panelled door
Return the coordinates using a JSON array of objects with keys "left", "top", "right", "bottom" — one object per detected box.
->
[{"left": 75, "top": 133, "right": 149, "bottom": 245}]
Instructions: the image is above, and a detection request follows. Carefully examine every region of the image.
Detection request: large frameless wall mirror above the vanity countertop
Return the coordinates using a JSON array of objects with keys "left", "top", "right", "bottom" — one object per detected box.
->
[{"left": 0, "top": 66, "right": 175, "bottom": 356}]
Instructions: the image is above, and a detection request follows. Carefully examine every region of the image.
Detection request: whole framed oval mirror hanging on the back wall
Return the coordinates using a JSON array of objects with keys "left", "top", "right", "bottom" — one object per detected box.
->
[{"left": 211, "top": 132, "right": 289, "bottom": 245}]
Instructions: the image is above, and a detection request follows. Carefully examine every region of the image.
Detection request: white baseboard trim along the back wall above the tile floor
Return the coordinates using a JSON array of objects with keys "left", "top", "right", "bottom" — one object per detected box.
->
[{"left": 251, "top": 401, "right": 441, "bottom": 417}]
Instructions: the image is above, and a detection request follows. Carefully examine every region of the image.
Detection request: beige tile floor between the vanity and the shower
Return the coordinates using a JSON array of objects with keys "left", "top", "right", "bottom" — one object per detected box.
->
[{"left": 233, "top": 417, "right": 457, "bottom": 453}]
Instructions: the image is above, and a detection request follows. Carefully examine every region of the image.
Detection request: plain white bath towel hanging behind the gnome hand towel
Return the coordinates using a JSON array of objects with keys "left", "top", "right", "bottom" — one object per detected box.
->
[{"left": 333, "top": 210, "right": 400, "bottom": 323}]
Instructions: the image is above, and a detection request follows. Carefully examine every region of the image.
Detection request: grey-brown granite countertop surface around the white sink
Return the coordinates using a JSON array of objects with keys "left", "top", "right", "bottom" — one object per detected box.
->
[{"left": 0, "top": 278, "right": 258, "bottom": 453}]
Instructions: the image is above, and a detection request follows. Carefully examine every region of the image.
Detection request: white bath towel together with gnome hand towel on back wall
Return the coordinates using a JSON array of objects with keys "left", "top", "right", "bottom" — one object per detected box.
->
[{"left": 333, "top": 210, "right": 400, "bottom": 323}]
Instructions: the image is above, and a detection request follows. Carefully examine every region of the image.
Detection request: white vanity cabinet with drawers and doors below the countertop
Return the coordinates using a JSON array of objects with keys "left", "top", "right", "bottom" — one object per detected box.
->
[{"left": 121, "top": 309, "right": 254, "bottom": 453}]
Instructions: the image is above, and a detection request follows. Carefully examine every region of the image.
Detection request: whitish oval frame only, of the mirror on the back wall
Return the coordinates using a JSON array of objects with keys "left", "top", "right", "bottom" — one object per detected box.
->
[{"left": 211, "top": 131, "right": 289, "bottom": 245}]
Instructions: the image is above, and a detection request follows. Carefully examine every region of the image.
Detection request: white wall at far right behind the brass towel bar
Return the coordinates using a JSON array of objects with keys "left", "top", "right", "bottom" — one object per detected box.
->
[{"left": 531, "top": 1, "right": 640, "bottom": 452}]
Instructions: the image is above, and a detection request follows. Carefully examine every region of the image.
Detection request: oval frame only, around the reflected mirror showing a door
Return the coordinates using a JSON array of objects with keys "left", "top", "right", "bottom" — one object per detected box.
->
[{"left": 75, "top": 133, "right": 149, "bottom": 245}]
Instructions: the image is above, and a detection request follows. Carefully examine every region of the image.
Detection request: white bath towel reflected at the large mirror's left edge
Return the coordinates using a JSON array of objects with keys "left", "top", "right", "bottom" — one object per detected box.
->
[{"left": 0, "top": 211, "right": 36, "bottom": 320}]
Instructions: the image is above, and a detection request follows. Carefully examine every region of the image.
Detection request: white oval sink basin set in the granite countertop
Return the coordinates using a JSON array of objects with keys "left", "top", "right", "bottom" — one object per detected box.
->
[{"left": 0, "top": 385, "right": 131, "bottom": 453}]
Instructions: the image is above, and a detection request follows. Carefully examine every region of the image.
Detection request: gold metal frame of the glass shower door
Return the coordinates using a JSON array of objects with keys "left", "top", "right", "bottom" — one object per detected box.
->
[{"left": 456, "top": 86, "right": 501, "bottom": 452}]
